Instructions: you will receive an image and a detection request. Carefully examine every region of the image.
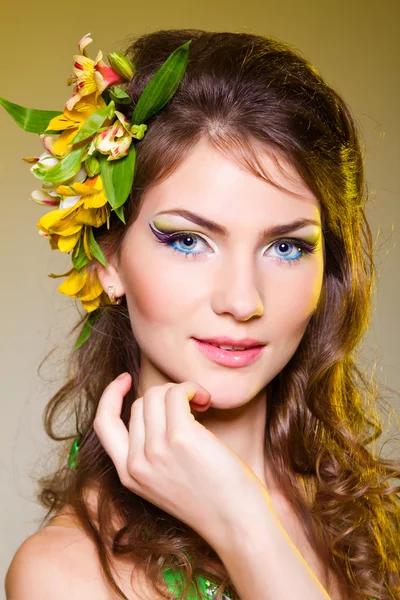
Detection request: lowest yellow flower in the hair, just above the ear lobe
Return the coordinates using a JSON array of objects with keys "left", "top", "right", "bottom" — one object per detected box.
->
[{"left": 58, "top": 268, "right": 104, "bottom": 312}]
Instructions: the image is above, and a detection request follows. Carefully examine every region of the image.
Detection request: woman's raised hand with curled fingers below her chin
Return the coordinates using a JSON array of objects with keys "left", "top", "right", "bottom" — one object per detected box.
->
[{"left": 93, "top": 373, "right": 266, "bottom": 544}]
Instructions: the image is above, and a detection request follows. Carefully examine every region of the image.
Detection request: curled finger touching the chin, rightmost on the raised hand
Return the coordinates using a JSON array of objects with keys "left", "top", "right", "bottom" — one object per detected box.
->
[{"left": 165, "top": 381, "right": 211, "bottom": 437}]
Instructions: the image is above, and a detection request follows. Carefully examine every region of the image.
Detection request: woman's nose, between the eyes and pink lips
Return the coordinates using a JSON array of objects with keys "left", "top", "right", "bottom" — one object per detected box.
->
[{"left": 212, "top": 252, "right": 264, "bottom": 321}]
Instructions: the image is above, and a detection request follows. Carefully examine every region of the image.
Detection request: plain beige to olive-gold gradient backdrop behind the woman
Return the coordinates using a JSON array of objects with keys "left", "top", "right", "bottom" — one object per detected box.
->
[{"left": 0, "top": 0, "right": 400, "bottom": 596}]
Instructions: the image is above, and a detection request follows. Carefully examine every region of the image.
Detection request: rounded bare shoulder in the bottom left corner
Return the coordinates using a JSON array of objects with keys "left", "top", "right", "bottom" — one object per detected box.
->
[{"left": 5, "top": 527, "right": 111, "bottom": 600}]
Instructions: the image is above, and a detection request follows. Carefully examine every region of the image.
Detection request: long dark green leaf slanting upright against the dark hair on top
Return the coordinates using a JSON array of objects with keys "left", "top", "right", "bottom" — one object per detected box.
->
[{"left": 132, "top": 40, "right": 192, "bottom": 125}]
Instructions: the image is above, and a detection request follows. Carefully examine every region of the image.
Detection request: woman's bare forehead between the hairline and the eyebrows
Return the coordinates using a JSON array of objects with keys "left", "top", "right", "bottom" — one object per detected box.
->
[{"left": 142, "top": 140, "right": 320, "bottom": 227}]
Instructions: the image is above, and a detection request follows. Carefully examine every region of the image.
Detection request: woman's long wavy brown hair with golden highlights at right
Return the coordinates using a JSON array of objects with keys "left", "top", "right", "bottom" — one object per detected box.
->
[{"left": 37, "top": 29, "right": 400, "bottom": 600}]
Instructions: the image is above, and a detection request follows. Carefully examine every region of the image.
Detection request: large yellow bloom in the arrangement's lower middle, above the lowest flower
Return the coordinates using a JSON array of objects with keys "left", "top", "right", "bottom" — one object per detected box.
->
[{"left": 36, "top": 175, "right": 110, "bottom": 252}]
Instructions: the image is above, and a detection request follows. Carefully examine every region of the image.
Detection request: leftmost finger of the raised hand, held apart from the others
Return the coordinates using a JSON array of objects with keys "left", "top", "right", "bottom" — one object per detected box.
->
[{"left": 93, "top": 373, "right": 132, "bottom": 480}]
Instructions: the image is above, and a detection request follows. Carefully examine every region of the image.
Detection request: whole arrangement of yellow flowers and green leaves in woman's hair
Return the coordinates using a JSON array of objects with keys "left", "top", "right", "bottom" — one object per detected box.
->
[{"left": 0, "top": 34, "right": 191, "bottom": 349}]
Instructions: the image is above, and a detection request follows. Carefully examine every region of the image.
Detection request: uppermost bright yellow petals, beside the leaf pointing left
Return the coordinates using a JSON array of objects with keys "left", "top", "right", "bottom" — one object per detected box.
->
[{"left": 47, "top": 91, "right": 106, "bottom": 156}]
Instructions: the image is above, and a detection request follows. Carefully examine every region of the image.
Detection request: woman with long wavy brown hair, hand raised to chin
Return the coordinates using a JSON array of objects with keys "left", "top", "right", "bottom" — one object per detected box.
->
[{"left": 6, "top": 30, "right": 400, "bottom": 600}]
